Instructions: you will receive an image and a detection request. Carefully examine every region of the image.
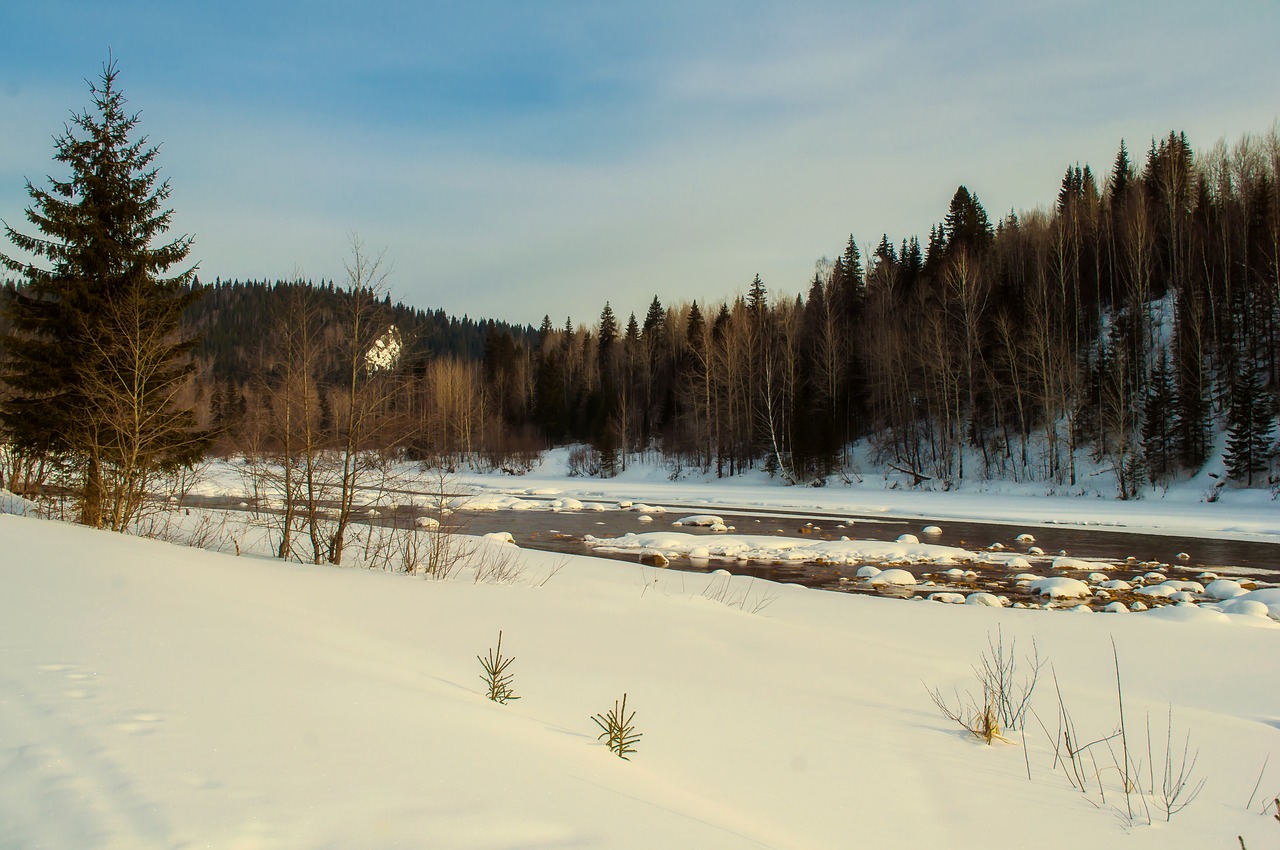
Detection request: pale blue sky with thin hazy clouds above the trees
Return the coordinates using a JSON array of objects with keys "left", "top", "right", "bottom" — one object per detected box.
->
[{"left": 0, "top": 0, "right": 1280, "bottom": 325}]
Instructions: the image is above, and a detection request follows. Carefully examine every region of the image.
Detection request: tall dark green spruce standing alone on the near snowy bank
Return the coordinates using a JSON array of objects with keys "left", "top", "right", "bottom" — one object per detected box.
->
[{"left": 0, "top": 61, "right": 209, "bottom": 530}]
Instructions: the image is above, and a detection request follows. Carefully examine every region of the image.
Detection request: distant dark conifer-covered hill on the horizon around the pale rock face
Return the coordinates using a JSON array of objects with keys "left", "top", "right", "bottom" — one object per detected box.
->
[{"left": 187, "top": 278, "right": 534, "bottom": 384}]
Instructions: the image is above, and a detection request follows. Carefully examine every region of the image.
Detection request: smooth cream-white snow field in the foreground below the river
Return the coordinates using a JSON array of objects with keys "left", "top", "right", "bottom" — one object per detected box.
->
[{"left": 0, "top": 491, "right": 1280, "bottom": 850}]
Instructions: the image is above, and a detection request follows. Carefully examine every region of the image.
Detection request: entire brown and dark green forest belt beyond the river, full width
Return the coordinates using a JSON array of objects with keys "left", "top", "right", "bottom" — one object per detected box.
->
[{"left": 4, "top": 69, "right": 1280, "bottom": 504}]
